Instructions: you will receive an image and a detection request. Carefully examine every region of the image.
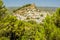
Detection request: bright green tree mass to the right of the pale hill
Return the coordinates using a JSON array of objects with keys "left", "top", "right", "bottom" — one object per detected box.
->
[{"left": 43, "top": 9, "right": 60, "bottom": 40}]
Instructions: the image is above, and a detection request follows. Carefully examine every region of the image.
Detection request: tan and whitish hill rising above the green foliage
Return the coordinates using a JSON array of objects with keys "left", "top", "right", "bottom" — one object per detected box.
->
[{"left": 14, "top": 4, "right": 48, "bottom": 23}]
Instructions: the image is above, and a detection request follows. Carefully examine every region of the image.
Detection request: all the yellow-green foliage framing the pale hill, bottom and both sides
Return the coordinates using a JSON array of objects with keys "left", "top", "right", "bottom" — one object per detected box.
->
[{"left": 0, "top": 0, "right": 60, "bottom": 40}]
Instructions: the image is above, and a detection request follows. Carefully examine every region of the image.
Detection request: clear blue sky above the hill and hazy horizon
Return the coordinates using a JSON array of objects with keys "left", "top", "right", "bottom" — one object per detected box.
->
[{"left": 3, "top": 0, "right": 60, "bottom": 7}]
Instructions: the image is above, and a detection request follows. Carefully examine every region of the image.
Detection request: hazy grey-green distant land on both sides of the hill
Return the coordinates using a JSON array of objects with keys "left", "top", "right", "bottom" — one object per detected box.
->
[{"left": 8, "top": 7, "right": 57, "bottom": 11}]
